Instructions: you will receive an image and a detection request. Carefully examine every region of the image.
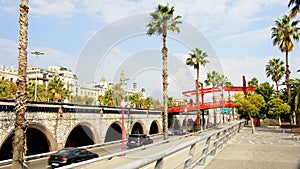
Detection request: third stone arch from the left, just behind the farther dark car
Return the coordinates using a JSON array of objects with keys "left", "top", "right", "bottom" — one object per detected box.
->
[{"left": 104, "top": 121, "right": 122, "bottom": 142}]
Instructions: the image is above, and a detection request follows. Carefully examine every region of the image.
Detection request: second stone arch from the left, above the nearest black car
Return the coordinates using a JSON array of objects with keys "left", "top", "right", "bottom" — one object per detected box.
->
[{"left": 65, "top": 122, "right": 99, "bottom": 147}]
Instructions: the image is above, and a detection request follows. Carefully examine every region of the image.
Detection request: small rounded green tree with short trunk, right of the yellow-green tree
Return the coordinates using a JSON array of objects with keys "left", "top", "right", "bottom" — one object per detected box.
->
[{"left": 267, "top": 97, "right": 291, "bottom": 125}]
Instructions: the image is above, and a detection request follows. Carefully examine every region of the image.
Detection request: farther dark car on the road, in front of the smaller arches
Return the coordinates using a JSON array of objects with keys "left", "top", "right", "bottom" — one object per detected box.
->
[{"left": 127, "top": 134, "right": 153, "bottom": 148}]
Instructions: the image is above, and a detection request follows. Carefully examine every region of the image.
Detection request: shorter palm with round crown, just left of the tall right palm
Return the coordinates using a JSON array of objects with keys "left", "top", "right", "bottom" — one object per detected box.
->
[{"left": 266, "top": 58, "right": 285, "bottom": 96}]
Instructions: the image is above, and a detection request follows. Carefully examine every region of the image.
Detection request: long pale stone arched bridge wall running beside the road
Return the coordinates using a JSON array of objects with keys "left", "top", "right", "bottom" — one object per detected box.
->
[{"left": 0, "top": 99, "right": 196, "bottom": 161}]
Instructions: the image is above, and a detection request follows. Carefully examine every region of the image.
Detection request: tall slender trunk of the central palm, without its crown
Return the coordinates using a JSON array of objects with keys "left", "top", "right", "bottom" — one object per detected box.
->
[{"left": 162, "top": 24, "right": 168, "bottom": 140}]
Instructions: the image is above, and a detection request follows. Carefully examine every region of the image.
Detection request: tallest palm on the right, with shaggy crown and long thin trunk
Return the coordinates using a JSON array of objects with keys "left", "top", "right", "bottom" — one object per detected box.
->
[{"left": 271, "top": 15, "right": 300, "bottom": 124}]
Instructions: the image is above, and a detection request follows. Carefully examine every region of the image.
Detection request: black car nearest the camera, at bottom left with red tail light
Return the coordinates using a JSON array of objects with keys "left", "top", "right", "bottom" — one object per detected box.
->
[{"left": 48, "top": 147, "right": 99, "bottom": 168}]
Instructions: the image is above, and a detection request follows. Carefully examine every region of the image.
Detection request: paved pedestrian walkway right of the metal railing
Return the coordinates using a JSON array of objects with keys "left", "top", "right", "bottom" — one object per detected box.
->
[{"left": 197, "top": 127, "right": 300, "bottom": 169}]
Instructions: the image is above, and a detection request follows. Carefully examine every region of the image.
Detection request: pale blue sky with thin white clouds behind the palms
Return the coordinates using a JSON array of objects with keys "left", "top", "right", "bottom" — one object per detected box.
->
[{"left": 0, "top": 0, "right": 300, "bottom": 97}]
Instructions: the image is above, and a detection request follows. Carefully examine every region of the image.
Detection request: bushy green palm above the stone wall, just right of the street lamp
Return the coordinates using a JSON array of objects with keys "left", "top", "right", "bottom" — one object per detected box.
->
[{"left": 47, "top": 77, "right": 64, "bottom": 101}]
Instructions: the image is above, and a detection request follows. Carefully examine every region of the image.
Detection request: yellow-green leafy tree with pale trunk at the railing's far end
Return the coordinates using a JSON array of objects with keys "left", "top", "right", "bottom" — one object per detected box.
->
[{"left": 234, "top": 93, "right": 265, "bottom": 134}]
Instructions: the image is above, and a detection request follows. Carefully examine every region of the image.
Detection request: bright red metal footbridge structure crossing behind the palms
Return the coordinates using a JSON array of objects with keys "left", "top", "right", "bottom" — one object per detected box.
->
[{"left": 168, "top": 76, "right": 255, "bottom": 114}]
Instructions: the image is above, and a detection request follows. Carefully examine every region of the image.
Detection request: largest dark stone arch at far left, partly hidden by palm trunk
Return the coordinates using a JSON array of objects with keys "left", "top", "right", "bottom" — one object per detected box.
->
[{"left": 0, "top": 122, "right": 57, "bottom": 161}]
